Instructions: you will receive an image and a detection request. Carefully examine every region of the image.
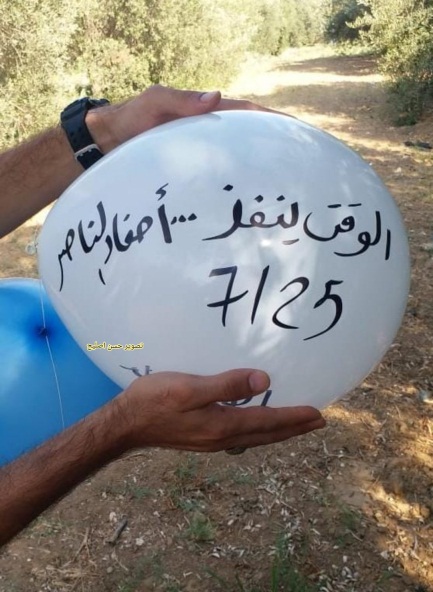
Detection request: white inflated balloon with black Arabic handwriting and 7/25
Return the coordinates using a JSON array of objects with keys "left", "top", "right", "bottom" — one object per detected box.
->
[{"left": 39, "top": 111, "right": 409, "bottom": 407}]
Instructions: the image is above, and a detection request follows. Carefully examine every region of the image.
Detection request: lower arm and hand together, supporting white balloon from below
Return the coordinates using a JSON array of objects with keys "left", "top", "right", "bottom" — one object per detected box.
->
[{"left": 0, "top": 369, "right": 325, "bottom": 546}]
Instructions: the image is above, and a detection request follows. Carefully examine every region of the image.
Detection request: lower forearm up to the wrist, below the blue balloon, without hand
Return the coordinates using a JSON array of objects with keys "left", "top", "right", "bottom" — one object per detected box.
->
[{"left": 0, "top": 399, "right": 128, "bottom": 546}]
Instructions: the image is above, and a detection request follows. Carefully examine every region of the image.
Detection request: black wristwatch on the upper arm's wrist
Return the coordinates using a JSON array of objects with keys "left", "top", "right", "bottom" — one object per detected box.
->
[{"left": 60, "top": 97, "right": 110, "bottom": 169}]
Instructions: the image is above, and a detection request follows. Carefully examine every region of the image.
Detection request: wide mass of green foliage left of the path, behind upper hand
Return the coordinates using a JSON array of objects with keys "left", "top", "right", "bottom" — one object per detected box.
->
[{"left": 0, "top": 0, "right": 322, "bottom": 148}]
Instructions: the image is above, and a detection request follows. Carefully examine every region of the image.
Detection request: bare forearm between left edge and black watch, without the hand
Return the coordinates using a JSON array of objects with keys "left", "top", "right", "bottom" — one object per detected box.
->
[{"left": 0, "top": 127, "right": 83, "bottom": 237}]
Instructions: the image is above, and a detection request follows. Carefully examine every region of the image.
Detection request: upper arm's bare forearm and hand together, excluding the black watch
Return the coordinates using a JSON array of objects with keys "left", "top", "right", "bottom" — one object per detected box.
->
[{"left": 0, "top": 86, "right": 258, "bottom": 238}]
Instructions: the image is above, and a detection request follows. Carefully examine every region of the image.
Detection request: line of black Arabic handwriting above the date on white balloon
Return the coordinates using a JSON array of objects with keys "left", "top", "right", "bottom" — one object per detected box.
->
[{"left": 57, "top": 183, "right": 391, "bottom": 291}]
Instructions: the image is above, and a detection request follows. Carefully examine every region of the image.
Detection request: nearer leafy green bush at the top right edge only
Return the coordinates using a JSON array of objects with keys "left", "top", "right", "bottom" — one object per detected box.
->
[{"left": 358, "top": 0, "right": 433, "bottom": 125}]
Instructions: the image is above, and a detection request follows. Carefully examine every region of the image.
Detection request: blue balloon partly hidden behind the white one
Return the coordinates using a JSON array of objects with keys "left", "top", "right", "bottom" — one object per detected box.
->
[{"left": 0, "top": 278, "right": 121, "bottom": 466}]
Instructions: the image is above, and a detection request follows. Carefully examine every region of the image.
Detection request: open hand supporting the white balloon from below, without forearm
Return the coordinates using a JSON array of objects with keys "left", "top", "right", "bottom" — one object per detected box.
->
[{"left": 116, "top": 369, "right": 325, "bottom": 452}]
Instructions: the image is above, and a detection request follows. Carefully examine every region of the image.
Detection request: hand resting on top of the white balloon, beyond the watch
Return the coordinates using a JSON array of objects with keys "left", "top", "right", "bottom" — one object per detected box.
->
[{"left": 86, "top": 85, "right": 269, "bottom": 154}]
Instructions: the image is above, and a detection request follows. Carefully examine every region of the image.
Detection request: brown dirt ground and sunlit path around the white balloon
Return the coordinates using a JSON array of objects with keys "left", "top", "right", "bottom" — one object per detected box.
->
[{"left": 0, "top": 48, "right": 433, "bottom": 592}]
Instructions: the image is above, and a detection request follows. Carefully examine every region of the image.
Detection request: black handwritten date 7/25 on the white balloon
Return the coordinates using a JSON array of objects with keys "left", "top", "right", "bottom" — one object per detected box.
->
[{"left": 207, "top": 265, "right": 343, "bottom": 341}]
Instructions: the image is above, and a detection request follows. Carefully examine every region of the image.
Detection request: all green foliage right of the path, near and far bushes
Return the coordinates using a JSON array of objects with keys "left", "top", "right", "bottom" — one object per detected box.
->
[{"left": 323, "top": 0, "right": 433, "bottom": 125}]
